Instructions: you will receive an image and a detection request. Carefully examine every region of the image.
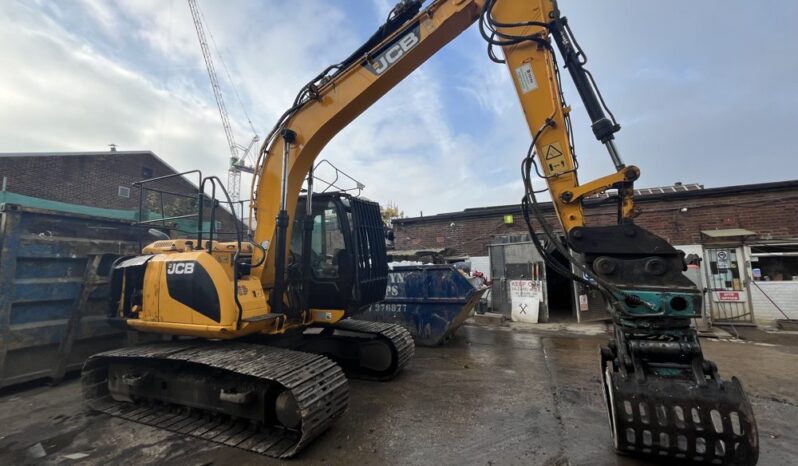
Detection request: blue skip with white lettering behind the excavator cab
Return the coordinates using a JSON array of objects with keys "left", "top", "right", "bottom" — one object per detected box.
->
[{"left": 355, "top": 265, "right": 488, "bottom": 346}]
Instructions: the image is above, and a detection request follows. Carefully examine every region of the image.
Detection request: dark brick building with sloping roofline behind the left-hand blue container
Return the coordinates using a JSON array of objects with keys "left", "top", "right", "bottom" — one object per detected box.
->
[{"left": 0, "top": 150, "right": 242, "bottom": 236}]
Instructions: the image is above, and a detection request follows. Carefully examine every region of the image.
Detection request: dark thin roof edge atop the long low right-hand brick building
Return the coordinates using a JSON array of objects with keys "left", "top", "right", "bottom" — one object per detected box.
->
[{"left": 392, "top": 180, "right": 798, "bottom": 225}]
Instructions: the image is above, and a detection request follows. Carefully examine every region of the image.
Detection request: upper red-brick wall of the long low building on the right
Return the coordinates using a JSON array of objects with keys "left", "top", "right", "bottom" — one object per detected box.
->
[{"left": 393, "top": 181, "right": 798, "bottom": 256}]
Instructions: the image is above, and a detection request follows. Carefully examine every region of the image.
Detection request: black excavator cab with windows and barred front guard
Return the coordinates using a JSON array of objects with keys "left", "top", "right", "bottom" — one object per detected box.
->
[{"left": 290, "top": 192, "right": 388, "bottom": 313}]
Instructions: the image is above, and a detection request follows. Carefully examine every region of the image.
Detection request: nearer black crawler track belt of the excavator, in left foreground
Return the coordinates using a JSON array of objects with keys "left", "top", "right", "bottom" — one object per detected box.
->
[{"left": 81, "top": 341, "right": 349, "bottom": 458}]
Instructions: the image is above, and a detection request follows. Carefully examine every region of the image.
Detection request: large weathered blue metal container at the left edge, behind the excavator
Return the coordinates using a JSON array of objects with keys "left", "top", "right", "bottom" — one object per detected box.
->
[{"left": 0, "top": 203, "right": 155, "bottom": 387}]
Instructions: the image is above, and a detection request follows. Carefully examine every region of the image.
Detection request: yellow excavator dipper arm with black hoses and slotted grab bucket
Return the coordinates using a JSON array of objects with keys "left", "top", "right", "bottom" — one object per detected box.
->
[{"left": 480, "top": 0, "right": 759, "bottom": 464}]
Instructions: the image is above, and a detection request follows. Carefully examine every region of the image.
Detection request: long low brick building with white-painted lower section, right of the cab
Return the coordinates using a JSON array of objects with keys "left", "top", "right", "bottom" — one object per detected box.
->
[{"left": 393, "top": 180, "right": 798, "bottom": 323}]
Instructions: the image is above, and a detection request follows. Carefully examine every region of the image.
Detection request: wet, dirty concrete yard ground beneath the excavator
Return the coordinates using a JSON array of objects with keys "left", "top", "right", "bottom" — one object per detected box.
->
[{"left": 0, "top": 324, "right": 798, "bottom": 466}]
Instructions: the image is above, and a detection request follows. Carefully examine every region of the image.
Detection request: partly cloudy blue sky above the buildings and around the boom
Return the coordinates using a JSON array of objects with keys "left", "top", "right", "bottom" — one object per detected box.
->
[{"left": 0, "top": 0, "right": 798, "bottom": 216}]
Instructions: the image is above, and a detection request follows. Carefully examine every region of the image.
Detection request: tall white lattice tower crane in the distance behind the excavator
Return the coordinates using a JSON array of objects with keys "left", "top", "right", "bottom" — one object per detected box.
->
[{"left": 188, "top": 0, "right": 260, "bottom": 202}]
